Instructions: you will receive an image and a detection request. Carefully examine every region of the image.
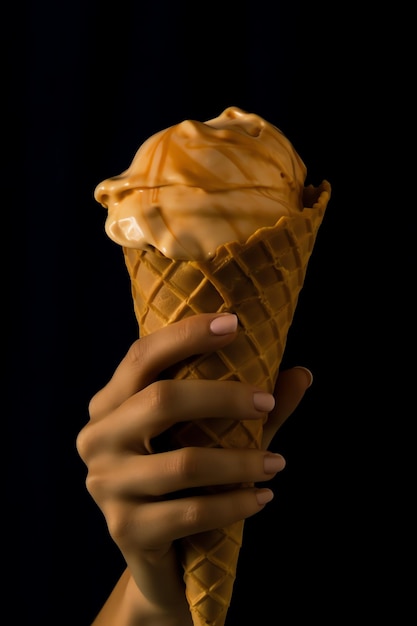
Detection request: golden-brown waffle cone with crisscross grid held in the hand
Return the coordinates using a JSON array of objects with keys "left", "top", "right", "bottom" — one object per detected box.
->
[{"left": 124, "top": 181, "right": 330, "bottom": 626}]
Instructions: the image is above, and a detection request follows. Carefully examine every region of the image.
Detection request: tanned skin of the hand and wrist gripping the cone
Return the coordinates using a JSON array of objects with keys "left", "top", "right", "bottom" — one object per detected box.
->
[{"left": 77, "top": 314, "right": 311, "bottom": 626}]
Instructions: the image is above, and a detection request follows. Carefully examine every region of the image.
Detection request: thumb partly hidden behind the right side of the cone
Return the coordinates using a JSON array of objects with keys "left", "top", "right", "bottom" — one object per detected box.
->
[{"left": 262, "top": 366, "right": 313, "bottom": 448}]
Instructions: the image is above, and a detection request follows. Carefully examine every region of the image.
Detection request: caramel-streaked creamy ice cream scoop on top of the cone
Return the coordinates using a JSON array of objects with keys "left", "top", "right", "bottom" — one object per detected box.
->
[{"left": 95, "top": 107, "right": 306, "bottom": 260}]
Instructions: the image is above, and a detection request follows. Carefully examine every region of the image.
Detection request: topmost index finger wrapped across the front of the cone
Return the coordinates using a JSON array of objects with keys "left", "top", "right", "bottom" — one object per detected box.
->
[{"left": 90, "top": 313, "right": 237, "bottom": 418}]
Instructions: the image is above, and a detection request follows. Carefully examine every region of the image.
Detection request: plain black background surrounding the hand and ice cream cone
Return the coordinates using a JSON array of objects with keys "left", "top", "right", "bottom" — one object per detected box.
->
[{"left": 8, "top": 0, "right": 407, "bottom": 626}]
